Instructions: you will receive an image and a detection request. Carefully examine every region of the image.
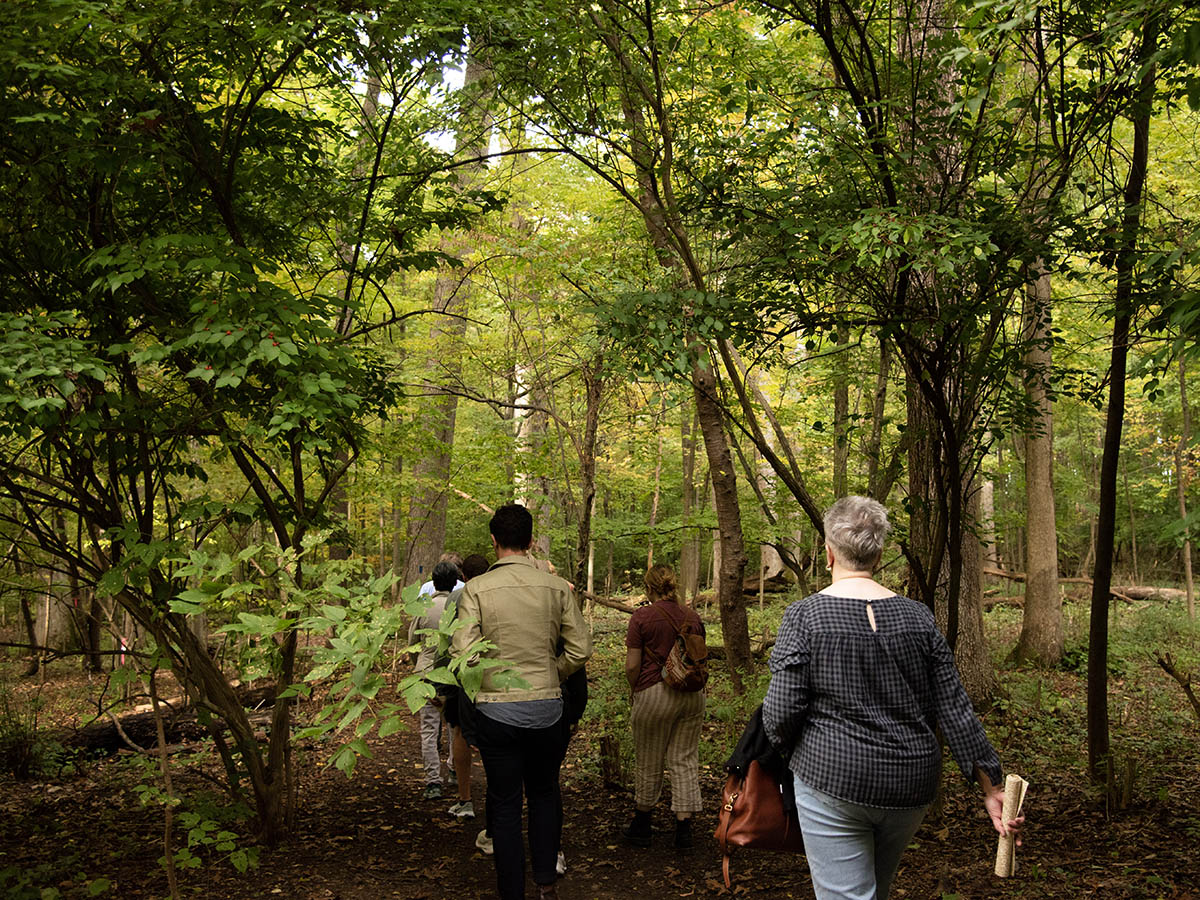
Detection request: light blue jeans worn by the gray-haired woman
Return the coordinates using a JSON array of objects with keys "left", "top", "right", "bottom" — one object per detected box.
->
[{"left": 796, "top": 779, "right": 929, "bottom": 900}]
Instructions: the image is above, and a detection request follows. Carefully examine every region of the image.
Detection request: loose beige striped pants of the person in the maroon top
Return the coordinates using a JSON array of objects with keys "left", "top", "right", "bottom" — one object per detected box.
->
[{"left": 630, "top": 682, "right": 704, "bottom": 814}]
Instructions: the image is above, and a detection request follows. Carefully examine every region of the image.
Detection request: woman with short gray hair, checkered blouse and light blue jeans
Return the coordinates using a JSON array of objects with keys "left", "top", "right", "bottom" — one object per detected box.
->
[{"left": 762, "top": 497, "right": 1021, "bottom": 900}]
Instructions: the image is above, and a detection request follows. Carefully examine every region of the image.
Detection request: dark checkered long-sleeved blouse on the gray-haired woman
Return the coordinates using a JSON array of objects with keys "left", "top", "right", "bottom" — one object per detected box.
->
[{"left": 762, "top": 593, "right": 1003, "bottom": 809}]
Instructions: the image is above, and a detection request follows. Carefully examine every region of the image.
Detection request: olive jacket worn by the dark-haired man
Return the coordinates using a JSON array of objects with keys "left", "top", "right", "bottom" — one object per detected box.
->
[{"left": 452, "top": 556, "right": 592, "bottom": 703}]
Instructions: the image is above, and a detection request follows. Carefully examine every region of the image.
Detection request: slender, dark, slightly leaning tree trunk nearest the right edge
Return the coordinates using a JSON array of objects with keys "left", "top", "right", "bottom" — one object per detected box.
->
[{"left": 1087, "top": 16, "right": 1158, "bottom": 787}]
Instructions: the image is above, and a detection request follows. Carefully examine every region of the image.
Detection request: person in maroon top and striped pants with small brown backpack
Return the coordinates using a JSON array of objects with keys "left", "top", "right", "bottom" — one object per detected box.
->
[{"left": 624, "top": 565, "right": 704, "bottom": 850}]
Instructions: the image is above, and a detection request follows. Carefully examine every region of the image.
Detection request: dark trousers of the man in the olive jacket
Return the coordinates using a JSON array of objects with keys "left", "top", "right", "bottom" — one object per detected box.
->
[{"left": 475, "top": 713, "right": 563, "bottom": 900}]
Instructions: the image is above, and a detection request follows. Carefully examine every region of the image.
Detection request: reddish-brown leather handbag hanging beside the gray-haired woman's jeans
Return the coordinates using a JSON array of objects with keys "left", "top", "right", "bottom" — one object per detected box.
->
[{"left": 713, "top": 761, "right": 804, "bottom": 888}]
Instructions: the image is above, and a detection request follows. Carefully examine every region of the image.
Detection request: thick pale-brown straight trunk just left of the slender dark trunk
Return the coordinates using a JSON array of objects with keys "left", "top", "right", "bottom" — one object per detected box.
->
[{"left": 1013, "top": 260, "right": 1063, "bottom": 667}]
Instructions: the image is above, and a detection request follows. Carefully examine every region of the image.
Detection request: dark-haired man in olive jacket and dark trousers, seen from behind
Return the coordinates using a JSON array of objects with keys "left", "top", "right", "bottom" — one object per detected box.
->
[{"left": 454, "top": 503, "right": 592, "bottom": 900}]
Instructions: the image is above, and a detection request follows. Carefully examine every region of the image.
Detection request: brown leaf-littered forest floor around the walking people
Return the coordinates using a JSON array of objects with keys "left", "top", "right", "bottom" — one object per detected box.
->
[{"left": 0, "top": 600, "right": 1200, "bottom": 900}]
